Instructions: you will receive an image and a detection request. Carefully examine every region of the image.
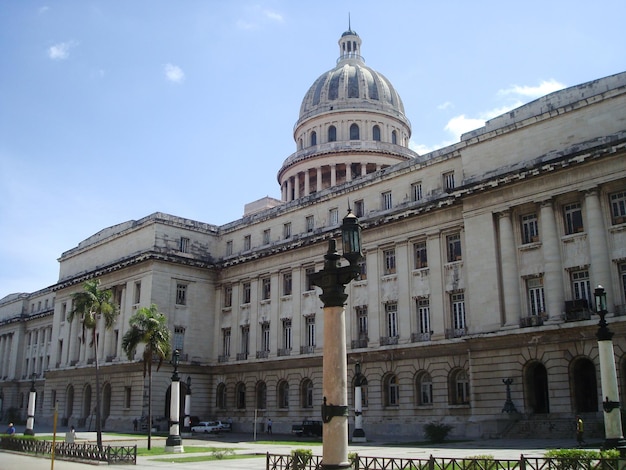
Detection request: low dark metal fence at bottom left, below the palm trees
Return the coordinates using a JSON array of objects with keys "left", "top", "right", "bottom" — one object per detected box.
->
[{"left": 0, "top": 437, "right": 137, "bottom": 465}]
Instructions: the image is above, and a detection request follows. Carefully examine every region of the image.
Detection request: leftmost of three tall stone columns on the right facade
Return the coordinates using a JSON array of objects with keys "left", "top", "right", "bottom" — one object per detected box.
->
[{"left": 498, "top": 210, "right": 521, "bottom": 326}]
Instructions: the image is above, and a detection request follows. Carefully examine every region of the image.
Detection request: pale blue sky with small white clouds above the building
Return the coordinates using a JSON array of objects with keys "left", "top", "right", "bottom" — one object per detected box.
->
[{"left": 0, "top": 0, "right": 626, "bottom": 298}]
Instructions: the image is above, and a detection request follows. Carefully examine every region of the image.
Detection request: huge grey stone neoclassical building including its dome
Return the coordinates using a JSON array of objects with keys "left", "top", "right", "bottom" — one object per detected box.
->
[{"left": 0, "top": 30, "right": 626, "bottom": 437}]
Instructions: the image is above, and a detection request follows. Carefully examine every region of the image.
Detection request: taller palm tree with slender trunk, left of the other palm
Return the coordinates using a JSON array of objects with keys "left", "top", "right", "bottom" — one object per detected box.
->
[{"left": 67, "top": 279, "right": 119, "bottom": 449}]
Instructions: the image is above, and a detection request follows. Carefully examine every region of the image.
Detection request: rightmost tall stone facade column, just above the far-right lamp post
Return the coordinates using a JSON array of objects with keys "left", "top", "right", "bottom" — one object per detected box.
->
[{"left": 585, "top": 188, "right": 614, "bottom": 312}]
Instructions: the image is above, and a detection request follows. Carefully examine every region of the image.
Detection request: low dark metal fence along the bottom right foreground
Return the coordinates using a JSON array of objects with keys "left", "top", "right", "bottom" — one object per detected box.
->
[{"left": 266, "top": 453, "right": 626, "bottom": 470}]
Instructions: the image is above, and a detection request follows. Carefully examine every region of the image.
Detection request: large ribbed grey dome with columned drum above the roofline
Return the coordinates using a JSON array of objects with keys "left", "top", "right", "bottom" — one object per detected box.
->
[{"left": 278, "top": 30, "right": 418, "bottom": 201}]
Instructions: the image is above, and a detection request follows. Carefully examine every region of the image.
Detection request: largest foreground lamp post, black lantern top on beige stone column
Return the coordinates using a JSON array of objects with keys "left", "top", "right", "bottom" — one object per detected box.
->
[{"left": 311, "top": 209, "right": 363, "bottom": 470}]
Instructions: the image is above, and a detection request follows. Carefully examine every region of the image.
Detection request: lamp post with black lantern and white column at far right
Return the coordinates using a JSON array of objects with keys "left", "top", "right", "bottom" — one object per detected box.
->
[{"left": 593, "top": 286, "right": 626, "bottom": 449}]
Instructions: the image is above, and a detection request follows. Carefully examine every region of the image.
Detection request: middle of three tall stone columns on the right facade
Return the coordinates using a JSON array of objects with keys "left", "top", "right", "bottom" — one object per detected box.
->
[{"left": 539, "top": 200, "right": 565, "bottom": 320}]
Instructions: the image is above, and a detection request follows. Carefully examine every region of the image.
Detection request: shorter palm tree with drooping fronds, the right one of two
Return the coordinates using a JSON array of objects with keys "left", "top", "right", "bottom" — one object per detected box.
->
[{"left": 122, "top": 304, "right": 172, "bottom": 450}]
